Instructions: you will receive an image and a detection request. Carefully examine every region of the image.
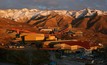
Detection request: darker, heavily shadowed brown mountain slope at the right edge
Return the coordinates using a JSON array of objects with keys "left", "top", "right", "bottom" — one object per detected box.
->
[{"left": 72, "top": 14, "right": 107, "bottom": 34}]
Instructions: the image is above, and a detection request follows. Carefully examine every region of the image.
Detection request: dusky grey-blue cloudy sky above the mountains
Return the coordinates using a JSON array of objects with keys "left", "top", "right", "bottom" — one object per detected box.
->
[{"left": 0, "top": 0, "right": 107, "bottom": 10}]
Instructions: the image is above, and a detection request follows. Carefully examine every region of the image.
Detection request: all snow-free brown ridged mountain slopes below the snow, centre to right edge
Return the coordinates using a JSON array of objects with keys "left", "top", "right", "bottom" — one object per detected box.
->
[{"left": 27, "top": 13, "right": 107, "bottom": 34}]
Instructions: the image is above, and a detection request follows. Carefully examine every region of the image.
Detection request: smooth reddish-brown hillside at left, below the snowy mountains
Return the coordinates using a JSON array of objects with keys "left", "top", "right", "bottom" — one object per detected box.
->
[{"left": 0, "top": 18, "right": 36, "bottom": 44}]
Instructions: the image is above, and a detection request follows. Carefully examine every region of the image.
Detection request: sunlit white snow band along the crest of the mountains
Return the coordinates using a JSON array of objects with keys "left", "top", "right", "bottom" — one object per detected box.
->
[{"left": 0, "top": 8, "right": 107, "bottom": 22}]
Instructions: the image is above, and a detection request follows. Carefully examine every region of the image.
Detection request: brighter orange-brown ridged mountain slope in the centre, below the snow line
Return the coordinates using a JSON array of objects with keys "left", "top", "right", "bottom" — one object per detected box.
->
[{"left": 27, "top": 12, "right": 74, "bottom": 27}]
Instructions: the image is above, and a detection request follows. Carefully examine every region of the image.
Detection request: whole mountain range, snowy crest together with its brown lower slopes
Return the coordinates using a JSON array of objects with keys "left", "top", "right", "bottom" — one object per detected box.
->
[{"left": 0, "top": 8, "right": 107, "bottom": 34}]
